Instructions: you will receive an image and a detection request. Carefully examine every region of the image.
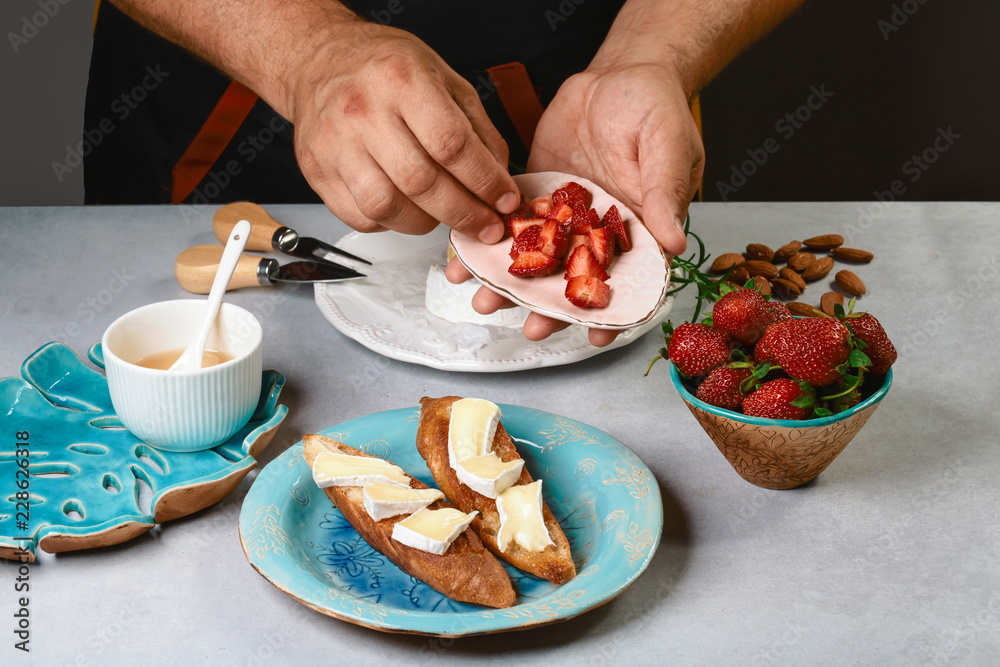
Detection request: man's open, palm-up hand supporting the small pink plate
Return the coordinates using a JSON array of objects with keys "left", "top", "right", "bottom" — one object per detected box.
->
[{"left": 528, "top": 64, "right": 705, "bottom": 255}]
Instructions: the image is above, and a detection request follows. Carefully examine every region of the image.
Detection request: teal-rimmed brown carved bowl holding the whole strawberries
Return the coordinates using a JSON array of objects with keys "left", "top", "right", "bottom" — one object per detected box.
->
[{"left": 670, "top": 364, "right": 892, "bottom": 489}]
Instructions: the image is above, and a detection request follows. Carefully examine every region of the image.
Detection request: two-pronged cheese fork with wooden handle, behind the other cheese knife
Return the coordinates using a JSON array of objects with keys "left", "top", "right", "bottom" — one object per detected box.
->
[{"left": 212, "top": 201, "right": 371, "bottom": 266}]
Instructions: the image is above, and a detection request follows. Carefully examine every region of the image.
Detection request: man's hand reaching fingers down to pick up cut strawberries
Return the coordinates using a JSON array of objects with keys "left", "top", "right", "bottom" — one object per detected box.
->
[{"left": 286, "top": 21, "right": 520, "bottom": 243}]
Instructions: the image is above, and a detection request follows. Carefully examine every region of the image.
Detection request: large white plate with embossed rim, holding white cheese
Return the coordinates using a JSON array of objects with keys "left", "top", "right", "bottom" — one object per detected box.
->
[{"left": 315, "top": 226, "right": 673, "bottom": 373}]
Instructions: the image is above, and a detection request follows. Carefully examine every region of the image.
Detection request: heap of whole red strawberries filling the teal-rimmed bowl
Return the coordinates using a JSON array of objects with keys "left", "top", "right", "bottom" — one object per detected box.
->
[{"left": 648, "top": 284, "right": 896, "bottom": 419}]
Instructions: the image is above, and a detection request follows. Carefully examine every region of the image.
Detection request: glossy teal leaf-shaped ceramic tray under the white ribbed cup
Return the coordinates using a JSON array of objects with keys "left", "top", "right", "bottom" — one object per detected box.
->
[{"left": 0, "top": 343, "right": 288, "bottom": 560}]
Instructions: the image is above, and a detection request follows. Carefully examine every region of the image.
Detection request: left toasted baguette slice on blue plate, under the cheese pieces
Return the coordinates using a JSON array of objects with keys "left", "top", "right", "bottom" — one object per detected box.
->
[{"left": 302, "top": 434, "right": 516, "bottom": 608}]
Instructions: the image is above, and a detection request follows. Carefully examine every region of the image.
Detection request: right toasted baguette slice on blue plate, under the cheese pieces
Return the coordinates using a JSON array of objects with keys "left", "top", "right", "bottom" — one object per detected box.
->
[{"left": 417, "top": 396, "right": 576, "bottom": 584}]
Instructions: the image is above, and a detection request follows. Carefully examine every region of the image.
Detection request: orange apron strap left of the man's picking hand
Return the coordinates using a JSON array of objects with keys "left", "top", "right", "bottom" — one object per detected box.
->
[{"left": 170, "top": 81, "right": 257, "bottom": 204}]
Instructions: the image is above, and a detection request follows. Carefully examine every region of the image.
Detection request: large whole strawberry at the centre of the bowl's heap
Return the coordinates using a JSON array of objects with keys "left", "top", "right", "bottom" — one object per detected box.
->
[{"left": 757, "top": 317, "right": 851, "bottom": 387}]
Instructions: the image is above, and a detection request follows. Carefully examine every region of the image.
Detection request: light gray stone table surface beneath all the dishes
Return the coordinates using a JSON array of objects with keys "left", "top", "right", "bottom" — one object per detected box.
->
[{"left": 0, "top": 202, "right": 1000, "bottom": 665}]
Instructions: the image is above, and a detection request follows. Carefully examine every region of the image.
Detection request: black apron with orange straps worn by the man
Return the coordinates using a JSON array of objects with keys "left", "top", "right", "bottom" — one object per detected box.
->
[{"left": 81, "top": 0, "right": 623, "bottom": 204}]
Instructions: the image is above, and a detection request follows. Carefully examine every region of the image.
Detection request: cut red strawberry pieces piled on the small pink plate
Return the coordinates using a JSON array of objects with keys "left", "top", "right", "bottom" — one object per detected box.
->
[{"left": 504, "top": 182, "right": 632, "bottom": 308}]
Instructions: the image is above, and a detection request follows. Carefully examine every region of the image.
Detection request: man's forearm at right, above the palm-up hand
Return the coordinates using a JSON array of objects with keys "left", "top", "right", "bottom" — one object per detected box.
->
[{"left": 591, "top": 0, "right": 804, "bottom": 96}]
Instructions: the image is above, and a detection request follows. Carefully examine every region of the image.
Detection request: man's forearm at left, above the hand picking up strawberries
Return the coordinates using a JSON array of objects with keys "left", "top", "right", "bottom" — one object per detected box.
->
[{"left": 110, "top": 0, "right": 361, "bottom": 118}]
